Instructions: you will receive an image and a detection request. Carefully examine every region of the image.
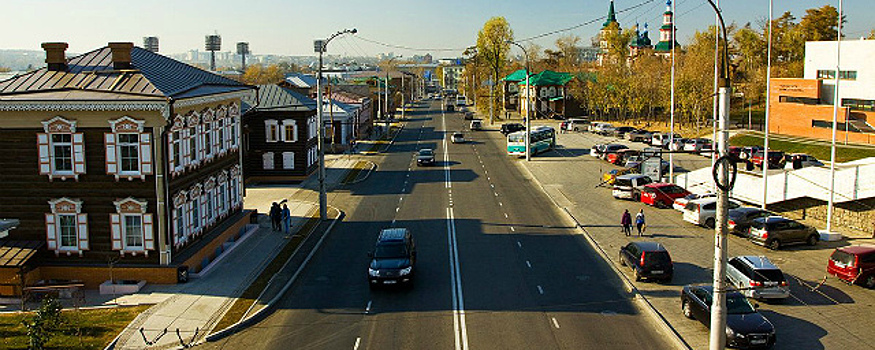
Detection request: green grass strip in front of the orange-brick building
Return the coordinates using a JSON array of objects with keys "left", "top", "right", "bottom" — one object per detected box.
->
[{"left": 729, "top": 134, "right": 875, "bottom": 163}]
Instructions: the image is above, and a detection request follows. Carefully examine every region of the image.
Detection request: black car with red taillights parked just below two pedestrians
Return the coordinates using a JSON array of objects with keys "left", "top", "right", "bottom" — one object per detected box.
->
[{"left": 620, "top": 242, "right": 674, "bottom": 282}]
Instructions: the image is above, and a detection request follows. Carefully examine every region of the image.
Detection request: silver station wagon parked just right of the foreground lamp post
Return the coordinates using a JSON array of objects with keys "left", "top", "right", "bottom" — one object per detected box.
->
[{"left": 726, "top": 255, "right": 790, "bottom": 300}]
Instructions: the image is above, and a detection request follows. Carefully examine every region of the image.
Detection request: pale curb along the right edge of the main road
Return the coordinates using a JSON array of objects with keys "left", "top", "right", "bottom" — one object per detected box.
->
[{"left": 521, "top": 161, "right": 692, "bottom": 350}]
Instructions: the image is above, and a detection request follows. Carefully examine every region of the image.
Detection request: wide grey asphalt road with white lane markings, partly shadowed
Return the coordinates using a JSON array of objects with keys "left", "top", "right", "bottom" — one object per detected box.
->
[{"left": 201, "top": 103, "right": 671, "bottom": 350}]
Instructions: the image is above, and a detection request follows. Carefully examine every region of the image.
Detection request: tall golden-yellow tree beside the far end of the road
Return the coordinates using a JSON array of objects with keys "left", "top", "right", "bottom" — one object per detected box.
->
[{"left": 477, "top": 17, "right": 513, "bottom": 123}]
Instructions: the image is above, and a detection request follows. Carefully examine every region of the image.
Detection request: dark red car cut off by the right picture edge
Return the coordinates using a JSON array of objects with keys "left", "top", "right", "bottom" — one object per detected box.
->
[{"left": 826, "top": 245, "right": 875, "bottom": 289}]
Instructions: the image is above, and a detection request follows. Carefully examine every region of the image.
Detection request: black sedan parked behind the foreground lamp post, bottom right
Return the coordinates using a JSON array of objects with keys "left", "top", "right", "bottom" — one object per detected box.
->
[{"left": 681, "top": 285, "right": 775, "bottom": 349}]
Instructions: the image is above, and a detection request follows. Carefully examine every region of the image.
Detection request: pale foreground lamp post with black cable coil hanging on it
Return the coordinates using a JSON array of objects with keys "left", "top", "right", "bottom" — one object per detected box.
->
[{"left": 708, "top": 0, "right": 732, "bottom": 350}]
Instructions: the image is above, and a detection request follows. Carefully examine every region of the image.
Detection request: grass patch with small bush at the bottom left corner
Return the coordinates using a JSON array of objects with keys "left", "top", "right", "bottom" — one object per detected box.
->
[{"left": 0, "top": 305, "right": 151, "bottom": 349}]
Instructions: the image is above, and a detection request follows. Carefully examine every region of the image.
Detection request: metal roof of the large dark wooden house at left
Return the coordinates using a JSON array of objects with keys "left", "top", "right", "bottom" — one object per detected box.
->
[{"left": 0, "top": 46, "right": 252, "bottom": 101}]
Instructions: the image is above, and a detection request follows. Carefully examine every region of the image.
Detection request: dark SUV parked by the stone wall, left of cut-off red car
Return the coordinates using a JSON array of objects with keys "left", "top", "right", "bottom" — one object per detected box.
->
[{"left": 747, "top": 216, "right": 820, "bottom": 250}]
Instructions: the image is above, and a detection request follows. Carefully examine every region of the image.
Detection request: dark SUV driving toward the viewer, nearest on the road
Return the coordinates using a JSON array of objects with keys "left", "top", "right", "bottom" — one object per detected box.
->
[{"left": 368, "top": 228, "right": 416, "bottom": 288}]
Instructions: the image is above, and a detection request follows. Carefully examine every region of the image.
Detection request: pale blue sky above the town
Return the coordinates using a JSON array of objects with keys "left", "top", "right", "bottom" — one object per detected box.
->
[{"left": 0, "top": 0, "right": 875, "bottom": 58}]
